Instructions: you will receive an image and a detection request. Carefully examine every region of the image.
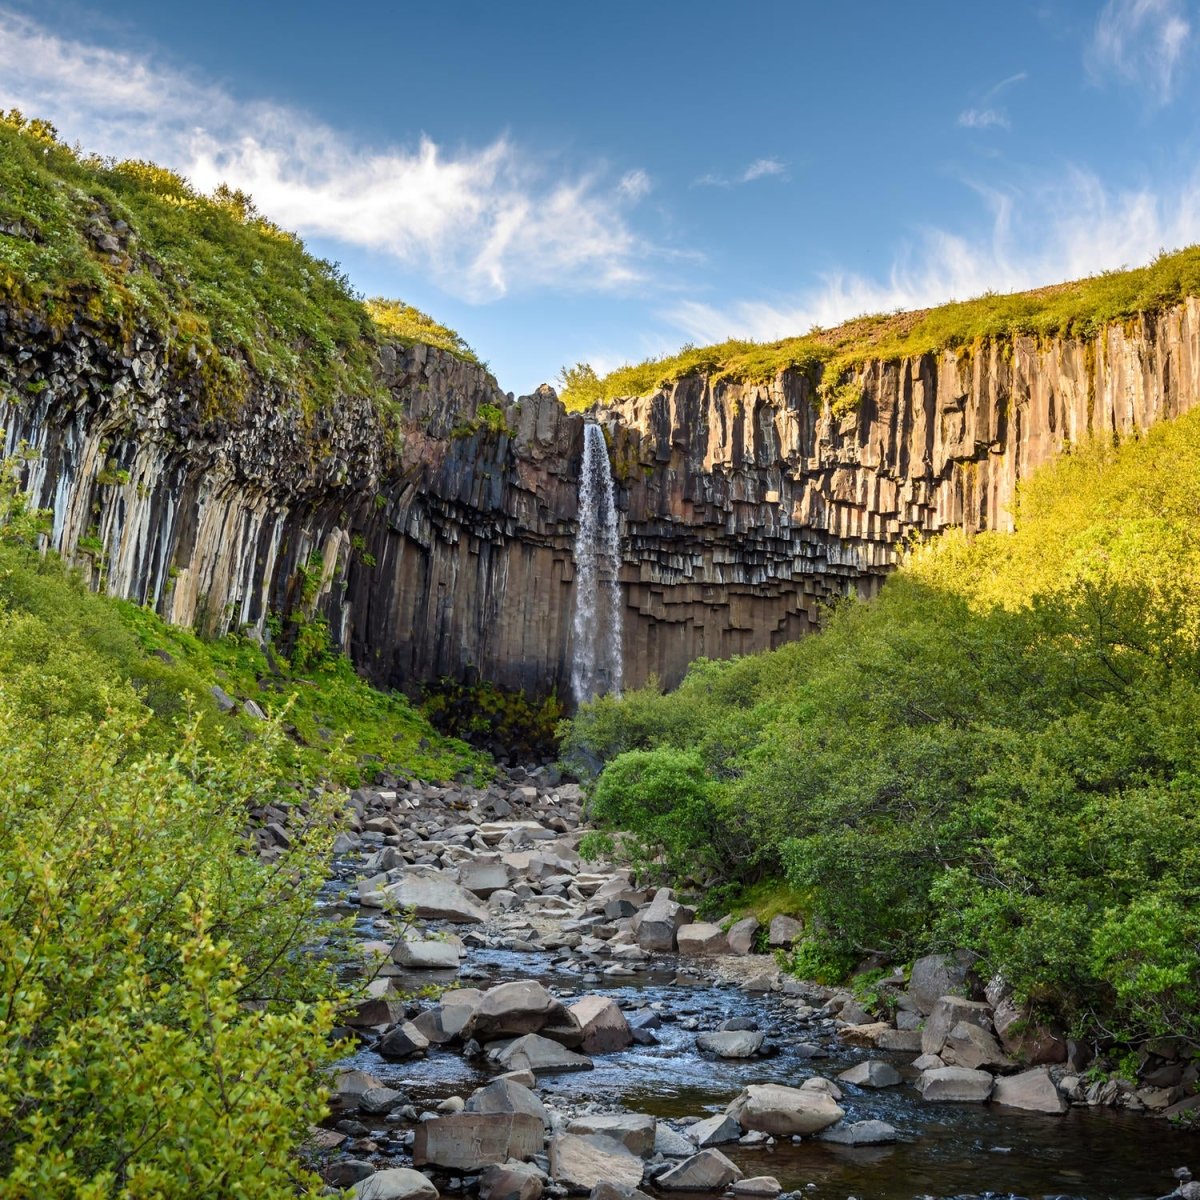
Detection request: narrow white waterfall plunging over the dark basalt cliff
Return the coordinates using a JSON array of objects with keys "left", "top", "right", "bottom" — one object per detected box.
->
[{"left": 571, "top": 422, "right": 622, "bottom": 704}]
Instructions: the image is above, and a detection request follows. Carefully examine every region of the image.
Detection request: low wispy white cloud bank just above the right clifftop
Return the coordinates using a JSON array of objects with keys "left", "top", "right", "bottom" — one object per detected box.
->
[{"left": 661, "top": 168, "right": 1200, "bottom": 342}]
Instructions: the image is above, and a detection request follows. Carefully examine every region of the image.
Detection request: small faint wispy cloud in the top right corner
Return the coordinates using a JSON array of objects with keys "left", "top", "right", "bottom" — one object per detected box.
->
[{"left": 1084, "top": 0, "right": 1193, "bottom": 104}]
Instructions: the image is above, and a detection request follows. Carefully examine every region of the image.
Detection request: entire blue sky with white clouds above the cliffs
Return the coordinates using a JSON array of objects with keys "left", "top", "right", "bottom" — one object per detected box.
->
[{"left": 0, "top": 0, "right": 1200, "bottom": 392}]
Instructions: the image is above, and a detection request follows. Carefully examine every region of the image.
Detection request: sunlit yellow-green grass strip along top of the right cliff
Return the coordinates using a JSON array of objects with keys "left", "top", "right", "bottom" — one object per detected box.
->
[{"left": 562, "top": 246, "right": 1200, "bottom": 410}]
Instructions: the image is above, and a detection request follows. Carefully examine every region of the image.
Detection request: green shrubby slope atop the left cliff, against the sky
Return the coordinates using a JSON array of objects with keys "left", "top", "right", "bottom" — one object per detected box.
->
[{"left": 0, "top": 112, "right": 478, "bottom": 412}]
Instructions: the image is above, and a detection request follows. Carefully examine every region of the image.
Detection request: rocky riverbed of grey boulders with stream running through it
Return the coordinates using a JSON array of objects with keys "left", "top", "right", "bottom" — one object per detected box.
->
[{"left": 276, "top": 768, "right": 1200, "bottom": 1200}]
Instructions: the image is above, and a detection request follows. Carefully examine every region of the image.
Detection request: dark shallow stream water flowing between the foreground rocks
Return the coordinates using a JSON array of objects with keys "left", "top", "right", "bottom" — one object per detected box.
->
[{"left": 333, "top": 936, "right": 1200, "bottom": 1200}]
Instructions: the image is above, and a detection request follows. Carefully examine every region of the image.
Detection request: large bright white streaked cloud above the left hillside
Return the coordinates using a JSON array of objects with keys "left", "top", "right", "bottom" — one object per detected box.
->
[{"left": 0, "top": 8, "right": 654, "bottom": 301}]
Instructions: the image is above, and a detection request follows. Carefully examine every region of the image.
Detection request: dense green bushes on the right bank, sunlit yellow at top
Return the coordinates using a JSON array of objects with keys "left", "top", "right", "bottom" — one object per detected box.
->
[{"left": 563, "top": 413, "right": 1200, "bottom": 1038}]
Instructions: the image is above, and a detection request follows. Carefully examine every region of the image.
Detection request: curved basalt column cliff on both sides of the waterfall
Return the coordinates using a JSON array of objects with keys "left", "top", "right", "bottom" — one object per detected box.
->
[{"left": 0, "top": 300, "right": 1200, "bottom": 696}]
